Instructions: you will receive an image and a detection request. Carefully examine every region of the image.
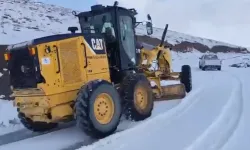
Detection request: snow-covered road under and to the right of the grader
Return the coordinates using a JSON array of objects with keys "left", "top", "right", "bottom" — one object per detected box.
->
[{"left": 0, "top": 54, "right": 247, "bottom": 150}]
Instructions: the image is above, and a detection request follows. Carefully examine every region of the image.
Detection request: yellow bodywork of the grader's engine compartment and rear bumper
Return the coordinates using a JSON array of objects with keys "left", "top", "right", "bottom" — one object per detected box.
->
[{"left": 13, "top": 36, "right": 110, "bottom": 122}]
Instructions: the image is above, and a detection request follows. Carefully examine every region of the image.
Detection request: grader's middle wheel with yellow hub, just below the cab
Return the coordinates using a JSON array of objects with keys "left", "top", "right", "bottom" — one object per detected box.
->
[{"left": 121, "top": 74, "right": 154, "bottom": 121}]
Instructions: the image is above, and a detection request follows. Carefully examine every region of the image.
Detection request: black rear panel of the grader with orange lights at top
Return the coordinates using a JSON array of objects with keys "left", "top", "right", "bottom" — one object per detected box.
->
[{"left": 5, "top": 42, "right": 41, "bottom": 89}]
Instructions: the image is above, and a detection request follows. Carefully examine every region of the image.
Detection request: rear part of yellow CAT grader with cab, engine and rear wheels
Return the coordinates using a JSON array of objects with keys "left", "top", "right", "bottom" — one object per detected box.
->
[{"left": 4, "top": 2, "right": 191, "bottom": 138}]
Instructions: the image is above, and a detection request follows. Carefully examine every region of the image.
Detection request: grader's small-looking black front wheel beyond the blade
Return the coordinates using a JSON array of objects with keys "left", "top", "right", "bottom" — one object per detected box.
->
[{"left": 180, "top": 65, "right": 192, "bottom": 93}]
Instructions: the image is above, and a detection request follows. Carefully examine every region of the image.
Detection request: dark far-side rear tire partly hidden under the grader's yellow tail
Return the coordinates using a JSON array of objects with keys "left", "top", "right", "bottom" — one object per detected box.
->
[{"left": 18, "top": 112, "right": 58, "bottom": 132}]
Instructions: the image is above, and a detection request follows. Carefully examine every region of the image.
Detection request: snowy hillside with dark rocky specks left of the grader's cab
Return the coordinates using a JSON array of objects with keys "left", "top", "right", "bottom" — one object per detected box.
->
[{"left": 0, "top": 0, "right": 77, "bottom": 44}]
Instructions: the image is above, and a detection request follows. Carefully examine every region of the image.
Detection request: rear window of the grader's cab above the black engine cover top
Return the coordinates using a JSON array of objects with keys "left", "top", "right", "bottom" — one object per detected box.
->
[{"left": 79, "top": 12, "right": 112, "bottom": 33}]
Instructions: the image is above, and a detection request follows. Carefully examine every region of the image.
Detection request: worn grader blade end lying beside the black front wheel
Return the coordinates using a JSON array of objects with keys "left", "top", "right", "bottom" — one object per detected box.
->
[{"left": 155, "top": 84, "right": 186, "bottom": 101}]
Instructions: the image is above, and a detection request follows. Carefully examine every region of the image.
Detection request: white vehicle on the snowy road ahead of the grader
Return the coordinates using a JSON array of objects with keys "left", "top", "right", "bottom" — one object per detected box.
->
[{"left": 199, "top": 54, "right": 222, "bottom": 70}]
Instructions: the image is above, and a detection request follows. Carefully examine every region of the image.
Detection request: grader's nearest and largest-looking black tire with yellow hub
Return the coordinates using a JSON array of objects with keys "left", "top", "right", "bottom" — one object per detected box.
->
[{"left": 75, "top": 80, "right": 122, "bottom": 138}]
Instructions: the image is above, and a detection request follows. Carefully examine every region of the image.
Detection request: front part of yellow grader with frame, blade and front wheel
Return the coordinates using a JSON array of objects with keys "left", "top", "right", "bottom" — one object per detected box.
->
[{"left": 137, "top": 23, "right": 192, "bottom": 100}]
